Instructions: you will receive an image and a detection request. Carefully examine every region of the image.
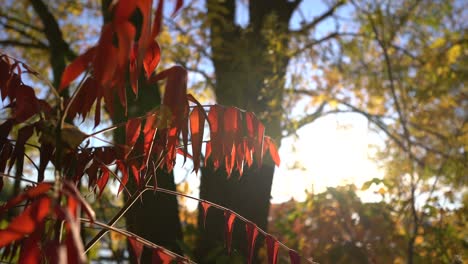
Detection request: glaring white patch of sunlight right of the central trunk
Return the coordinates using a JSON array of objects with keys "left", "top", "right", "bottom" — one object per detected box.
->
[{"left": 272, "top": 114, "right": 383, "bottom": 203}]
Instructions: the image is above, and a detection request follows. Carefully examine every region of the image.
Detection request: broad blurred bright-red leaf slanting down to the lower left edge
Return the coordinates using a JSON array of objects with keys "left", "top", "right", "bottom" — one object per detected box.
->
[{"left": 0, "top": 197, "right": 51, "bottom": 248}]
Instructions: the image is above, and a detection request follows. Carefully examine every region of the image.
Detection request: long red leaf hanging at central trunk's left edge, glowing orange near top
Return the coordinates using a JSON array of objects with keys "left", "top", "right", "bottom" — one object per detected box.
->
[{"left": 190, "top": 106, "right": 205, "bottom": 173}]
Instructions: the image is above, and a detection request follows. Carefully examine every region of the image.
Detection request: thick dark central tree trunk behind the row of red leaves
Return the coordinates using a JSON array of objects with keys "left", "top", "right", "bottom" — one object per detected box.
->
[{"left": 196, "top": 0, "right": 300, "bottom": 263}]
